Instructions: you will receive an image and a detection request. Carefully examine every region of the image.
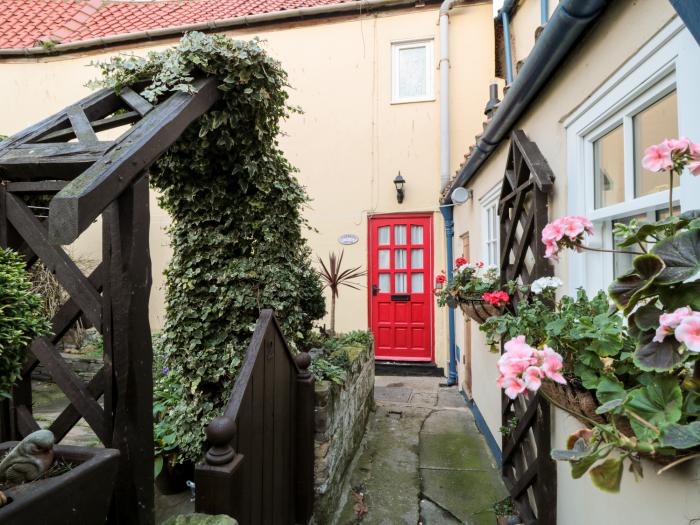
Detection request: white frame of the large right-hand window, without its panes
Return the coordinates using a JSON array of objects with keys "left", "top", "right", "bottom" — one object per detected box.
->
[{"left": 564, "top": 17, "right": 700, "bottom": 293}]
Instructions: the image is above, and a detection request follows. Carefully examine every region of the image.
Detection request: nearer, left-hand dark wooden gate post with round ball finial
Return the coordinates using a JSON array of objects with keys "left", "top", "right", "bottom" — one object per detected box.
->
[{"left": 194, "top": 416, "right": 243, "bottom": 516}]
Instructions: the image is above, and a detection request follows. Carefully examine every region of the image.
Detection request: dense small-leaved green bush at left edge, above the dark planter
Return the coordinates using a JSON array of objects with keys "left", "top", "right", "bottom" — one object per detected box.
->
[{"left": 0, "top": 248, "right": 50, "bottom": 398}]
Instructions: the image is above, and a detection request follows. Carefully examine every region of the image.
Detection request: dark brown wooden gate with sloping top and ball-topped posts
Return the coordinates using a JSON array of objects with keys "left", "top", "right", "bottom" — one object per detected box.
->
[{"left": 195, "top": 310, "right": 315, "bottom": 525}]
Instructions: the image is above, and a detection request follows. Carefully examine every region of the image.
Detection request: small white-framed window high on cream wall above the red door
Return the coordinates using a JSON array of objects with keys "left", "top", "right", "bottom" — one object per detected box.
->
[{"left": 391, "top": 40, "right": 435, "bottom": 104}]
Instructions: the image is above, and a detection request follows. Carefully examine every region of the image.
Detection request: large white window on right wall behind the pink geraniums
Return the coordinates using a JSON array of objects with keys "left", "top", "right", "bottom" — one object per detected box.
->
[{"left": 564, "top": 18, "right": 700, "bottom": 292}]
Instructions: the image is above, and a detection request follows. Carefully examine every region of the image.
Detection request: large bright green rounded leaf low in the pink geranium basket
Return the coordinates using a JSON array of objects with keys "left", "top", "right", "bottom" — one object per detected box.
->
[{"left": 624, "top": 376, "right": 683, "bottom": 441}]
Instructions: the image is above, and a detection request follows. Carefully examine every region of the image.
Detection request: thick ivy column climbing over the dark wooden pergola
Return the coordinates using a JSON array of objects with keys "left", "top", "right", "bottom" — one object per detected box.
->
[{"left": 89, "top": 33, "right": 325, "bottom": 462}]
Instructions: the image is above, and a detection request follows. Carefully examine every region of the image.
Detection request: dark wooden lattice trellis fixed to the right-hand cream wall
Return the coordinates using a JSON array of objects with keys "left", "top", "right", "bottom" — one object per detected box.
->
[{"left": 498, "top": 130, "right": 557, "bottom": 525}]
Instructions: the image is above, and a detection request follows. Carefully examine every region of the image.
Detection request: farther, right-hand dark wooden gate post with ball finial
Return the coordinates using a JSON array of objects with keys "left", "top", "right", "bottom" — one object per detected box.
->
[{"left": 295, "top": 352, "right": 316, "bottom": 523}]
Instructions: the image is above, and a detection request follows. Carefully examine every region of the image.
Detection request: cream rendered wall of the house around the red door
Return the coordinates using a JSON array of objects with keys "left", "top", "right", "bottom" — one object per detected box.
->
[{"left": 0, "top": 3, "right": 494, "bottom": 366}]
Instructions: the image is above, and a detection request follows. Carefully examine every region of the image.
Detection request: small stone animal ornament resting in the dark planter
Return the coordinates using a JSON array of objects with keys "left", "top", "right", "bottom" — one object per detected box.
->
[{"left": 0, "top": 430, "right": 54, "bottom": 485}]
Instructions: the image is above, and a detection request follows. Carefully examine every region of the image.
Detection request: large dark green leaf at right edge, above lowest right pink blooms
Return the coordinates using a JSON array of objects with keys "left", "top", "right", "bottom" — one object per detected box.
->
[{"left": 651, "top": 230, "right": 700, "bottom": 284}]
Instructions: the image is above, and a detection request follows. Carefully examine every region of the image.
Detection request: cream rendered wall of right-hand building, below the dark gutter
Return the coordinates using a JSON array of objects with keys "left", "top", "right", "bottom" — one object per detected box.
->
[{"left": 455, "top": 0, "right": 700, "bottom": 525}]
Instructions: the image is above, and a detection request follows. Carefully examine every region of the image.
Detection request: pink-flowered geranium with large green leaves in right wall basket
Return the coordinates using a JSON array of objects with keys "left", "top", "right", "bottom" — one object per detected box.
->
[{"left": 491, "top": 138, "right": 700, "bottom": 492}]
